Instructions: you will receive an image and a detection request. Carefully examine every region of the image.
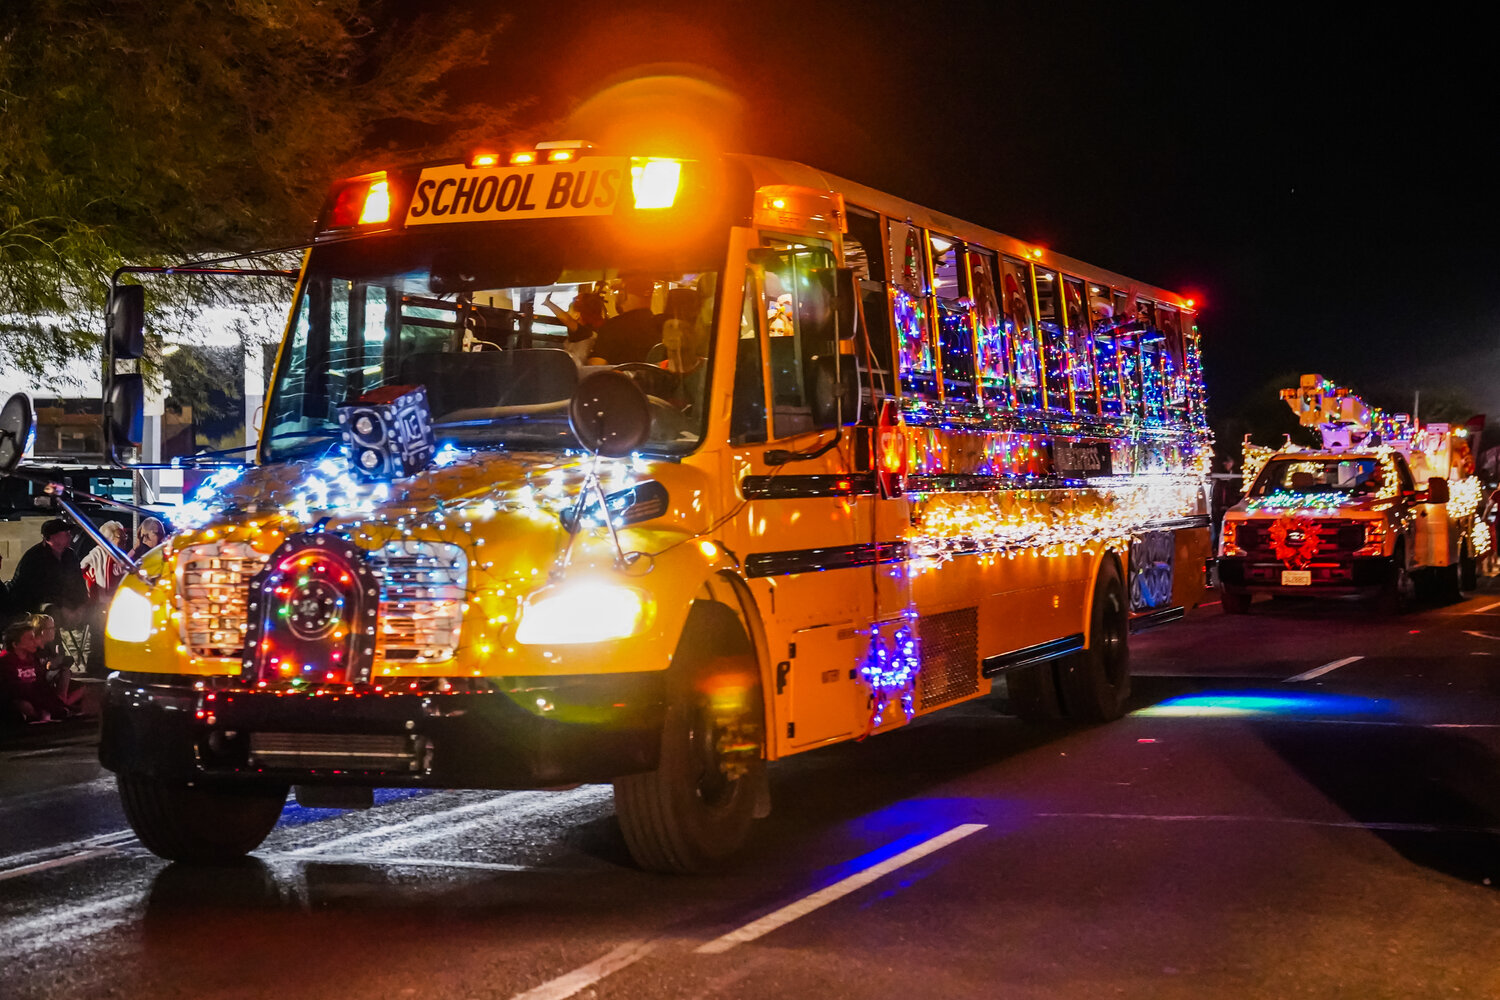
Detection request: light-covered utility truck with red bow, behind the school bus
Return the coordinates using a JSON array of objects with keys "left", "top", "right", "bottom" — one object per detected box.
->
[{"left": 1218, "top": 375, "right": 1490, "bottom": 615}]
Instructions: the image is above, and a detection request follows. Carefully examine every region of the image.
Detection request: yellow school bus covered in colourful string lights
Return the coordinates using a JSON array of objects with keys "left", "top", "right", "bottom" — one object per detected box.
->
[{"left": 101, "top": 142, "right": 1211, "bottom": 871}]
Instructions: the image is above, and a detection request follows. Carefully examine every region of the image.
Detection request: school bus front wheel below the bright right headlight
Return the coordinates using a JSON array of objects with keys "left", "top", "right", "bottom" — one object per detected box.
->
[{"left": 615, "top": 611, "right": 767, "bottom": 874}]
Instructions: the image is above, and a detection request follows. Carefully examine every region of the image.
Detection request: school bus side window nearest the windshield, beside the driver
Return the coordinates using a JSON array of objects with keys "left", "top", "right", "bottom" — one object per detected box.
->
[{"left": 765, "top": 246, "right": 837, "bottom": 438}]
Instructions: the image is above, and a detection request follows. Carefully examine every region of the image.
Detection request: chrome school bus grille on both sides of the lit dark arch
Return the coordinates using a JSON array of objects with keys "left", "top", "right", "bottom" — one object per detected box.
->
[{"left": 177, "top": 541, "right": 468, "bottom": 664}]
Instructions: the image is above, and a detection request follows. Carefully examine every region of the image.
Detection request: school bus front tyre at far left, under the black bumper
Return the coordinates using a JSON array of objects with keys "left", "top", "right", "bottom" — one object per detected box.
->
[{"left": 116, "top": 774, "right": 287, "bottom": 864}]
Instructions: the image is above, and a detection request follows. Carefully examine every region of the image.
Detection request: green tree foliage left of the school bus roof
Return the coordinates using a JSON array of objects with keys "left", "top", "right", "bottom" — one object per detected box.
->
[{"left": 0, "top": 0, "right": 510, "bottom": 389}]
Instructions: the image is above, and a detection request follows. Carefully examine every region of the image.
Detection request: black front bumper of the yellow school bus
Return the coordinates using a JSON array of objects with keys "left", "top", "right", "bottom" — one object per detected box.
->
[{"left": 99, "top": 672, "right": 666, "bottom": 789}]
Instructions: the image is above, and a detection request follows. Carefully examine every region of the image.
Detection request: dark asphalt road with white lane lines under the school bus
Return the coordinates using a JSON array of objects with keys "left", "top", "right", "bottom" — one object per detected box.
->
[{"left": 0, "top": 583, "right": 1500, "bottom": 1000}]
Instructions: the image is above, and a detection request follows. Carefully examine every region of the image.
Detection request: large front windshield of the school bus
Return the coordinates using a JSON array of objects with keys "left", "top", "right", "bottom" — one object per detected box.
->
[{"left": 263, "top": 223, "right": 723, "bottom": 462}]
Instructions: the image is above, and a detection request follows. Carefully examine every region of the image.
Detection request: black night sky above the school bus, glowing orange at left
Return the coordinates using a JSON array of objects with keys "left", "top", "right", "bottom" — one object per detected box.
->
[{"left": 438, "top": 0, "right": 1500, "bottom": 434}]
